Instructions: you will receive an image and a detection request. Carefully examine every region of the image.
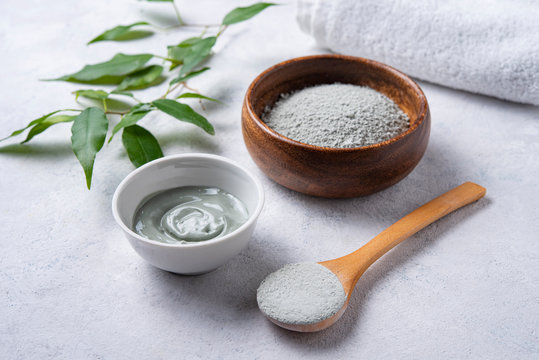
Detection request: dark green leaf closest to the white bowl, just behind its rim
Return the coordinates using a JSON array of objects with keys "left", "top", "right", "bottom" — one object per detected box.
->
[{"left": 122, "top": 125, "right": 163, "bottom": 167}]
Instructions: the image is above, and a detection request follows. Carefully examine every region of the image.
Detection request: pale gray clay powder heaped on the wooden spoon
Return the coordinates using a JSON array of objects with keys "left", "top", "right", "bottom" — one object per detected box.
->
[{"left": 256, "top": 263, "right": 346, "bottom": 325}]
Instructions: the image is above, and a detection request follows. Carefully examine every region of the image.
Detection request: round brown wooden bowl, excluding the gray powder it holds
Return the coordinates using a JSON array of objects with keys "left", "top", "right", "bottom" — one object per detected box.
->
[{"left": 242, "top": 55, "right": 430, "bottom": 198}]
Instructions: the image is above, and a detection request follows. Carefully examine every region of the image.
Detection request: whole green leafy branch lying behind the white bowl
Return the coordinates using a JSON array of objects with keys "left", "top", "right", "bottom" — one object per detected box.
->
[{"left": 0, "top": 0, "right": 275, "bottom": 189}]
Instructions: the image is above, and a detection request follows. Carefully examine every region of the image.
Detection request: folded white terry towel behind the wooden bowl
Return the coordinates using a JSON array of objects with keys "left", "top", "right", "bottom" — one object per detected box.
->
[{"left": 297, "top": 0, "right": 539, "bottom": 105}]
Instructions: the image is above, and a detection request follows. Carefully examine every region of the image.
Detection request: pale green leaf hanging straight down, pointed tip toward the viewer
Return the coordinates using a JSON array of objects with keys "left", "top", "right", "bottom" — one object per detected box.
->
[{"left": 71, "top": 107, "right": 109, "bottom": 189}]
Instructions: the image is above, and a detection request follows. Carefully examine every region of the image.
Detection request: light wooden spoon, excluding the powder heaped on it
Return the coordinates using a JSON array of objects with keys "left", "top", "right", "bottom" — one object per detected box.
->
[{"left": 262, "top": 182, "right": 486, "bottom": 332}]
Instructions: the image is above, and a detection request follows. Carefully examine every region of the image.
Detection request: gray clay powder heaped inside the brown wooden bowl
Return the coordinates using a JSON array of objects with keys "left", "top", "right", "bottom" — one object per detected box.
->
[{"left": 262, "top": 83, "right": 410, "bottom": 148}]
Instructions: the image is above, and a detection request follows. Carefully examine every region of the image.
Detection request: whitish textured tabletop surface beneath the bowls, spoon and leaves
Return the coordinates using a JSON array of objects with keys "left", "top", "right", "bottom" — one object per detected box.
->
[{"left": 0, "top": 0, "right": 539, "bottom": 359}]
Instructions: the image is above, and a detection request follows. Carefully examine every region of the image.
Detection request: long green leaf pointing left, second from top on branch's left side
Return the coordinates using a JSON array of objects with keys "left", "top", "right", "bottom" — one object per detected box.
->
[{"left": 51, "top": 53, "right": 153, "bottom": 84}]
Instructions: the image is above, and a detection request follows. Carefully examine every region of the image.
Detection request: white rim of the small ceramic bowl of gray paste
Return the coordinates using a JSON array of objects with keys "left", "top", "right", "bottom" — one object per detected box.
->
[{"left": 112, "top": 153, "right": 264, "bottom": 248}]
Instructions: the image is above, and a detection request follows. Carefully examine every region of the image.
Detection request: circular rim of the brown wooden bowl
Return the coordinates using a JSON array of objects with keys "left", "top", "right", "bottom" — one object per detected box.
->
[{"left": 245, "top": 54, "right": 428, "bottom": 153}]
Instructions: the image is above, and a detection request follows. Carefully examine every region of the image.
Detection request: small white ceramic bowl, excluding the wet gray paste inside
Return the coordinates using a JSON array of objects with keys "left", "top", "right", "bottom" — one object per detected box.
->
[{"left": 112, "top": 154, "right": 264, "bottom": 274}]
